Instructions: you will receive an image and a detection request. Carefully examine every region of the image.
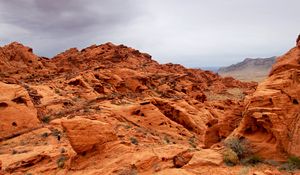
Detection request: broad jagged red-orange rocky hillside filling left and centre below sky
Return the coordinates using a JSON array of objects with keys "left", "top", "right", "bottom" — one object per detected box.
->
[{"left": 0, "top": 38, "right": 298, "bottom": 174}]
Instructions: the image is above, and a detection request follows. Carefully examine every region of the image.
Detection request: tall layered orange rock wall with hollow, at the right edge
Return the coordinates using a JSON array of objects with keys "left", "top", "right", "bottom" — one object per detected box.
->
[{"left": 236, "top": 44, "right": 300, "bottom": 159}]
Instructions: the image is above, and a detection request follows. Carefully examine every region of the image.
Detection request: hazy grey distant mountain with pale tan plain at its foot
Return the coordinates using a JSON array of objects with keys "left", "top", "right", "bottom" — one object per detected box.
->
[{"left": 217, "top": 56, "right": 276, "bottom": 82}]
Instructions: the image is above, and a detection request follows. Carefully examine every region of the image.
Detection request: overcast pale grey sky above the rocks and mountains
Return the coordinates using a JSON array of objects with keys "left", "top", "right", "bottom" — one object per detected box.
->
[{"left": 0, "top": 0, "right": 300, "bottom": 67}]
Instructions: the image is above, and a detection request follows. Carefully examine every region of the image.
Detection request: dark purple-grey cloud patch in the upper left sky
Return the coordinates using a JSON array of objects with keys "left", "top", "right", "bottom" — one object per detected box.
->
[{"left": 1, "top": 0, "right": 138, "bottom": 37}]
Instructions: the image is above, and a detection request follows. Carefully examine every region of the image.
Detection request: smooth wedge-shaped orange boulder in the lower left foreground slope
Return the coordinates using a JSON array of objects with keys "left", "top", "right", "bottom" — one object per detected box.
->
[{"left": 62, "top": 117, "right": 117, "bottom": 153}]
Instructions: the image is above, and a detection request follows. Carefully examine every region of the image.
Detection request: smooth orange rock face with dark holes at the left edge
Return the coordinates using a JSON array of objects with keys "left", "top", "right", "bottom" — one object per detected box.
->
[{"left": 0, "top": 82, "right": 40, "bottom": 140}]
